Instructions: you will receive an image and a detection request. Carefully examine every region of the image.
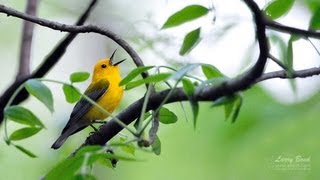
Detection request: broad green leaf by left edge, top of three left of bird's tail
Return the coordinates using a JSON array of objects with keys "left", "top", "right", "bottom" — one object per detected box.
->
[{"left": 4, "top": 106, "right": 44, "bottom": 127}]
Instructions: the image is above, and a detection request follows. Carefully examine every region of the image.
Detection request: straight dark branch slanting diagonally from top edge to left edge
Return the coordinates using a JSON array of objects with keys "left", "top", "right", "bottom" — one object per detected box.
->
[{"left": 0, "top": 0, "right": 97, "bottom": 124}]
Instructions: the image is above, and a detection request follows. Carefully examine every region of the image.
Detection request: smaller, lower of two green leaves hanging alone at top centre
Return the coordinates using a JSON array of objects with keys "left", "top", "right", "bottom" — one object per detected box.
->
[{"left": 179, "top": 27, "right": 201, "bottom": 56}]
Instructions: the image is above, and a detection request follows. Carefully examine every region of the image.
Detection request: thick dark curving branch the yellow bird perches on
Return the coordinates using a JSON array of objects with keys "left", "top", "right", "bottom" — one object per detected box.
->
[{"left": 76, "top": 0, "right": 269, "bottom": 149}]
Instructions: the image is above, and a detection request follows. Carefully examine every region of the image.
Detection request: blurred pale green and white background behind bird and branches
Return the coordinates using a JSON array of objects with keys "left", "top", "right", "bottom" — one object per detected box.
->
[{"left": 0, "top": 0, "right": 320, "bottom": 180}]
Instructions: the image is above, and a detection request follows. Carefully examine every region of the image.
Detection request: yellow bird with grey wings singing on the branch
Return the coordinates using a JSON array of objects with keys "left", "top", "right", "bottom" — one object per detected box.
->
[{"left": 51, "top": 50, "right": 125, "bottom": 149}]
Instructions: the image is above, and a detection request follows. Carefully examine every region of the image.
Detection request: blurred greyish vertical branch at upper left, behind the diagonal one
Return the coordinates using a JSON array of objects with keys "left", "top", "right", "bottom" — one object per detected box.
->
[{"left": 17, "top": 0, "right": 38, "bottom": 79}]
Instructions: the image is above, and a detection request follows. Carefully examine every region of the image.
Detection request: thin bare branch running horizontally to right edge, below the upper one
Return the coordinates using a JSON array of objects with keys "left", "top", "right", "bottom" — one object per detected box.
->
[{"left": 256, "top": 67, "right": 320, "bottom": 83}]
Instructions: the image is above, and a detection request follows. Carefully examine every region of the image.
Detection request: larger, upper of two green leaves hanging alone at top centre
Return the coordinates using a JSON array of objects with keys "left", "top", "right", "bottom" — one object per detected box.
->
[{"left": 161, "top": 5, "right": 209, "bottom": 29}]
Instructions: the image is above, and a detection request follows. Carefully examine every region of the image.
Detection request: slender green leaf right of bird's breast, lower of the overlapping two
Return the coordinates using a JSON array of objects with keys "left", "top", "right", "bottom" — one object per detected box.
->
[{"left": 125, "top": 73, "right": 171, "bottom": 90}]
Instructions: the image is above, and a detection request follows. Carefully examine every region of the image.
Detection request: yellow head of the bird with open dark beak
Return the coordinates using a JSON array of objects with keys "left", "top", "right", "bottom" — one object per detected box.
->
[{"left": 92, "top": 50, "right": 125, "bottom": 80}]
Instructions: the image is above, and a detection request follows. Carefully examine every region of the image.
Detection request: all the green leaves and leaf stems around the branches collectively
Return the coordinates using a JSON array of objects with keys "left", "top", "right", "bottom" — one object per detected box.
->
[{"left": 0, "top": 0, "right": 320, "bottom": 180}]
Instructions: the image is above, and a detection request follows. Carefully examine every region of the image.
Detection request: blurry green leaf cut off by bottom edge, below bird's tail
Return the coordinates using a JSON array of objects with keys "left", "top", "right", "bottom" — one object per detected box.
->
[{"left": 44, "top": 156, "right": 84, "bottom": 180}]
